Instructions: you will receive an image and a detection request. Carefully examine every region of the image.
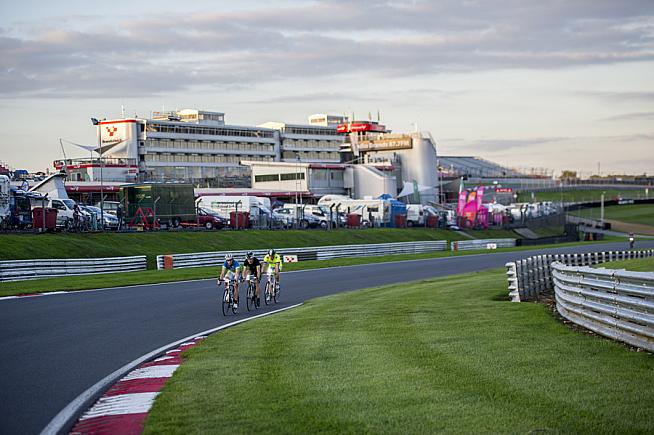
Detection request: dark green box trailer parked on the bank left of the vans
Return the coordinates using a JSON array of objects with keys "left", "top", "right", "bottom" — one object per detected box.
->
[{"left": 120, "top": 183, "right": 197, "bottom": 228}]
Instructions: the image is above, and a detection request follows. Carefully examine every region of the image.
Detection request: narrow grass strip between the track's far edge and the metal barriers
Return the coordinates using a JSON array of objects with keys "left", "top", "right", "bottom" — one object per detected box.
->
[{"left": 0, "top": 237, "right": 622, "bottom": 297}]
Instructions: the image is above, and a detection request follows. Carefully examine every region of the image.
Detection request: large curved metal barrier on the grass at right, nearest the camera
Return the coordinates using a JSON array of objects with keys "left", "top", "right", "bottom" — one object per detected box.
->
[{"left": 551, "top": 262, "right": 654, "bottom": 352}]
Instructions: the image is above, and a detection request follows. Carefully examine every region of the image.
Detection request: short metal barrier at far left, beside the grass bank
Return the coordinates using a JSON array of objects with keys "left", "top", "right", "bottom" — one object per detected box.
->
[{"left": 0, "top": 255, "right": 147, "bottom": 281}]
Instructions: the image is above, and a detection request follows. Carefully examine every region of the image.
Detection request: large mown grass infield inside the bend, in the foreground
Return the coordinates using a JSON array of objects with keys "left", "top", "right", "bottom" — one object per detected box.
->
[{"left": 145, "top": 270, "right": 654, "bottom": 434}]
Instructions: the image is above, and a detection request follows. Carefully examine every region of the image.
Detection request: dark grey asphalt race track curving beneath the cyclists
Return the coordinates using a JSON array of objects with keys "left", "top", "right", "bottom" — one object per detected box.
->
[{"left": 0, "top": 241, "right": 654, "bottom": 435}]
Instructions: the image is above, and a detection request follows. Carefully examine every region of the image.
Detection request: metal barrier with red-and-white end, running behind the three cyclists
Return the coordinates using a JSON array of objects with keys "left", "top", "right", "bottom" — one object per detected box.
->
[{"left": 157, "top": 240, "right": 447, "bottom": 269}]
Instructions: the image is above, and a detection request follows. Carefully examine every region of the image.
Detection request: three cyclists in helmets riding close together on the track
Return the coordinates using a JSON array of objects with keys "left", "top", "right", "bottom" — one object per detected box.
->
[{"left": 218, "top": 249, "right": 282, "bottom": 309}]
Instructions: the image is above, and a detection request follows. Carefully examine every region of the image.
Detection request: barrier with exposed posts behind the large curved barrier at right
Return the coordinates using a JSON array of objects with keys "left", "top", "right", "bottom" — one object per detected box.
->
[{"left": 506, "top": 249, "right": 654, "bottom": 302}]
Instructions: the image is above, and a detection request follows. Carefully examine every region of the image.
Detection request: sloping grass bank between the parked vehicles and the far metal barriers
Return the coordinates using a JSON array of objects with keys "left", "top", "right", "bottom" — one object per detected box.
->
[{"left": 0, "top": 228, "right": 502, "bottom": 269}]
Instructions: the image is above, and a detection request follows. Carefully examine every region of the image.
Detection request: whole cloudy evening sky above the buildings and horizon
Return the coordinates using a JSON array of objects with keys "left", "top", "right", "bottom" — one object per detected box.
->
[{"left": 0, "top": 0, "right": 654, "bottom": 175}]
